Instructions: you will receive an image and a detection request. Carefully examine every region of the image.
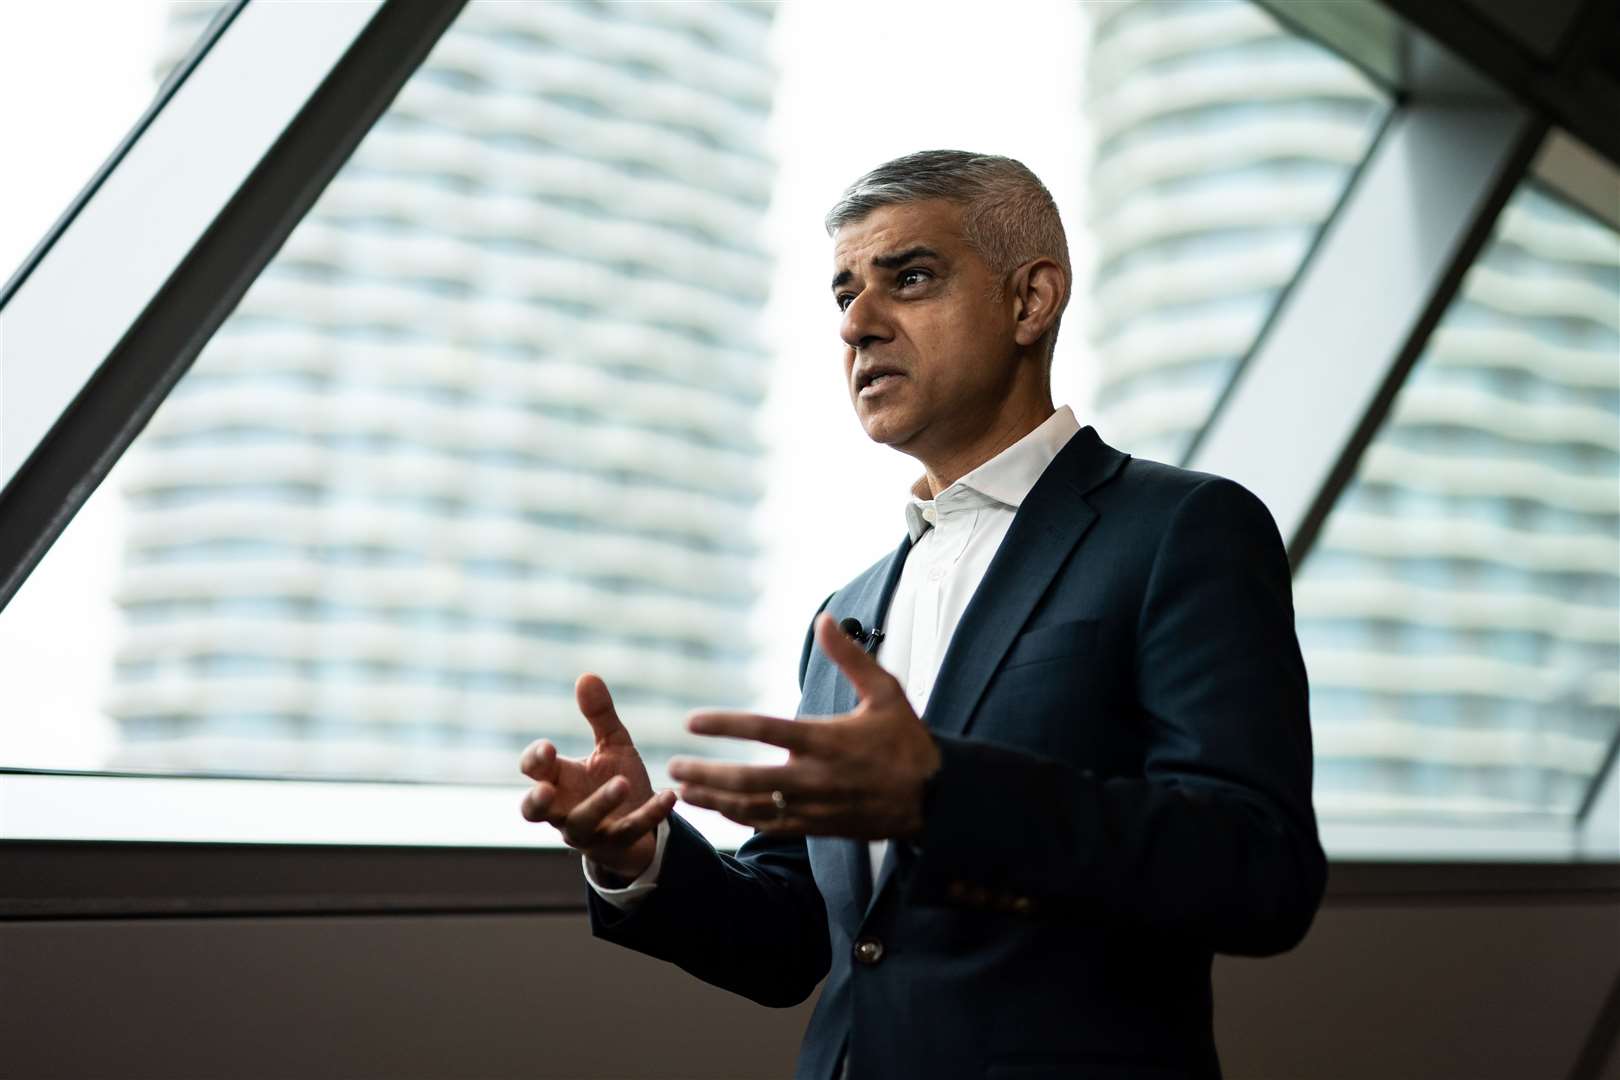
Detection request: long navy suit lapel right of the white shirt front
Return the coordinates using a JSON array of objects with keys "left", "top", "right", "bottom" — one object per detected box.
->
[{"left": 923, "top": 427, "right": 1126, "bottom": 735}]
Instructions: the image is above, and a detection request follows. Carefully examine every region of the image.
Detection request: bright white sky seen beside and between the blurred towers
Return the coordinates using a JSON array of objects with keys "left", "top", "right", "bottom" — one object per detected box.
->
[{"left": 0, "top": 0, "right": 1090, "bottom": 767}]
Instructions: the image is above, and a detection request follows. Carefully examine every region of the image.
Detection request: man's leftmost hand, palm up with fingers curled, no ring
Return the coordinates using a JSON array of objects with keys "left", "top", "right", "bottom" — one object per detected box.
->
[{"left": 518, "top": 674, "right": 676, "bottom": 881}]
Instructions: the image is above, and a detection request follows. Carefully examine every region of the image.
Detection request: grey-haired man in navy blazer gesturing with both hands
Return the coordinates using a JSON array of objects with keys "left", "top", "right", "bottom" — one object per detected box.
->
[{"left": 522, "top": 151, "right": 1325, "bottom": 1080}]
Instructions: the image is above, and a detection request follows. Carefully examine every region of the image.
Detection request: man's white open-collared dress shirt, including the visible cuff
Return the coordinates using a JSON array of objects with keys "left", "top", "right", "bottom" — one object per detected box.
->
[{"left": 585, "top": 405, "right": 1081, "bottom": 908}]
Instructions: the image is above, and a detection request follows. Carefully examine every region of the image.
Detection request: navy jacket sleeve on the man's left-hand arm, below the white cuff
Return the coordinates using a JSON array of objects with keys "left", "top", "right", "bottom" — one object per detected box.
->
[{"left": 586, "top": 596, "right": 833, "bottom": 1007}]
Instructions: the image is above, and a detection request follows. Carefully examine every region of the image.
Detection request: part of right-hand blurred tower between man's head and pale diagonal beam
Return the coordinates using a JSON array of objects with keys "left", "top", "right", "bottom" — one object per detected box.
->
[{"left": 1085, "top": 0, "right": 1385, "bottom": 461}]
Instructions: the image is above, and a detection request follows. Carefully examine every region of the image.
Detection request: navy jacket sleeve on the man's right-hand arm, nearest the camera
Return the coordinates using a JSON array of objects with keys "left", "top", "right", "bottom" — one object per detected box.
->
[{"left": 910, "top": 478, "right": 1327, "bottom": 955}]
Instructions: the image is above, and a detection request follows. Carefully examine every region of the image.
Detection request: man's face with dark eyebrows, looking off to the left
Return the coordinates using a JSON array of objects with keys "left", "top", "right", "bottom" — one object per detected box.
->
[{"left": 833, "top": 199, "right": 1016, "bottom": 457}]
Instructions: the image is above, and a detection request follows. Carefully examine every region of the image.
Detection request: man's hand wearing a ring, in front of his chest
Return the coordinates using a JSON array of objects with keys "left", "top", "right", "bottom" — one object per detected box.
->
[{"left": 669, "top": 614, "right": 940, "bottom": 840}]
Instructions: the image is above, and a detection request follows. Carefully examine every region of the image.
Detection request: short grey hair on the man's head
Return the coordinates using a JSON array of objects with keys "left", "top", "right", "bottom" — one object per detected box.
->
[{"left": 825, "top": 151, "right": 1074, "bottom": 291}]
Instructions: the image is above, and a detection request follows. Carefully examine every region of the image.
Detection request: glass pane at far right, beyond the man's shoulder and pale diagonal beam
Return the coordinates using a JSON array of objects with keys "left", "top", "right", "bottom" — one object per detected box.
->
[{"left": 1294, "top": 186, "right": 1620, "bottom": 853}]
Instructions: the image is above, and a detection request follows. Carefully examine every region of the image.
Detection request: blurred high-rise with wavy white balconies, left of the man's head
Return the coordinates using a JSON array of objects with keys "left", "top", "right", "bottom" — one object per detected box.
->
[{"left": 109, "top": 0, "right": 774, "bottom": 780}]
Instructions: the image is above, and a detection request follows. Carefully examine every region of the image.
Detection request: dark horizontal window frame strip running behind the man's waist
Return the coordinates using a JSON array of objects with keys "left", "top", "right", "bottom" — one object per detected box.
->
[{"left": 0, "top": 840, "right": 1620, "bottom": 921}]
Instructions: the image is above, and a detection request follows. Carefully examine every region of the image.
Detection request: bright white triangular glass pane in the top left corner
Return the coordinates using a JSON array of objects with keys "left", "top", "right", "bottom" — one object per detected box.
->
[{"left": 0, "top": 0, "right": 219, "bottom": 283}]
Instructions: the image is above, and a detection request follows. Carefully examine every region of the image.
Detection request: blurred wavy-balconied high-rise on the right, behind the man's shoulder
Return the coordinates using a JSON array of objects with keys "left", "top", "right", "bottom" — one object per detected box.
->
[{"left": 1087, "top": 0, "right": 1620, "bottom": 823}]
